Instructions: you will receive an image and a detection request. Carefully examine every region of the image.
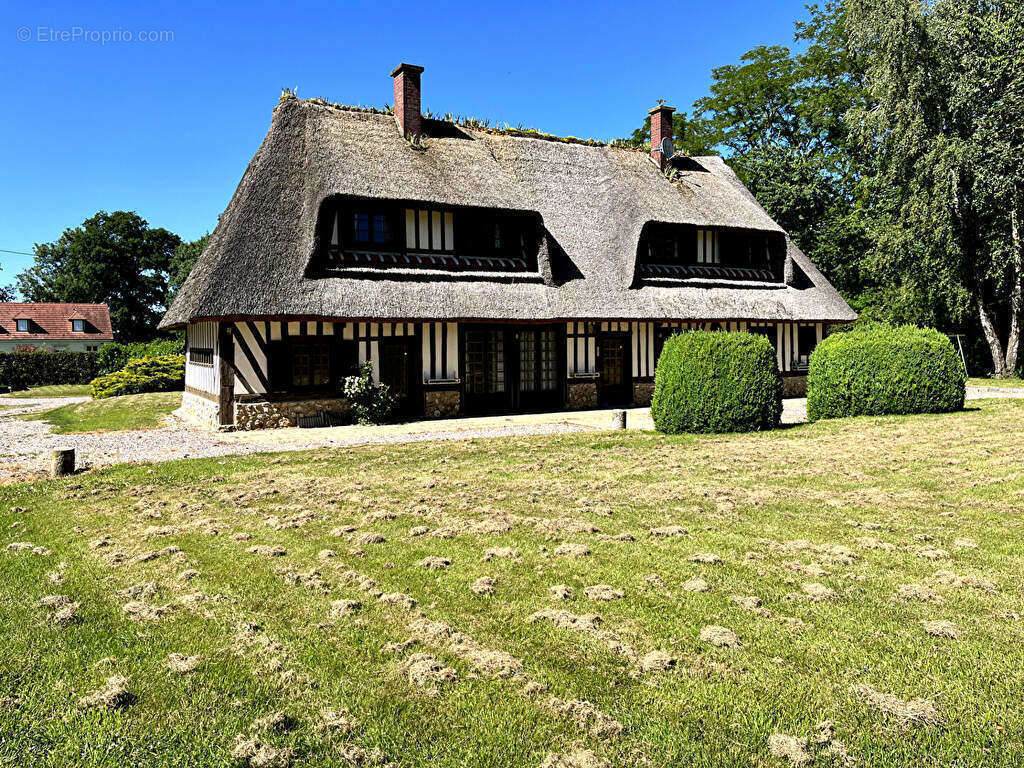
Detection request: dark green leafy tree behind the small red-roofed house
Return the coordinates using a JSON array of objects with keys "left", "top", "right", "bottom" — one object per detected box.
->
[{"left": 17, "top": 211, "right": 181, "bottom": 341}]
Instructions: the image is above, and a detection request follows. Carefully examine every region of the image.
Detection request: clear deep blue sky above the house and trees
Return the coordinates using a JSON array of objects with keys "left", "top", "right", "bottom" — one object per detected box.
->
[{"left": 0, "top": 0, "right": 805, "bottom": 285}]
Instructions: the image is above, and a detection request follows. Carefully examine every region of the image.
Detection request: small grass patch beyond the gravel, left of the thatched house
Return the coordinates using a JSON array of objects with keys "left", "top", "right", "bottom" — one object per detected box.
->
[{"left": 22, "top": 392, "right": 181, "bottom": 434}]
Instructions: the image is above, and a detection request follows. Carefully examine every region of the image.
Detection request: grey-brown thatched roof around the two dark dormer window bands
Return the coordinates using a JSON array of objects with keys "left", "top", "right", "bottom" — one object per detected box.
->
[{"left": 161, "top": 98, "right": 855, "bottom": 328}]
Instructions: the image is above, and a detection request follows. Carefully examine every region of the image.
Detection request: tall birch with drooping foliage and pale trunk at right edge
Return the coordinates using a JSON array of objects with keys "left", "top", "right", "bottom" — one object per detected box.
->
[{"left": 849, "top": 0, "right": 1024, "bottom": 377}]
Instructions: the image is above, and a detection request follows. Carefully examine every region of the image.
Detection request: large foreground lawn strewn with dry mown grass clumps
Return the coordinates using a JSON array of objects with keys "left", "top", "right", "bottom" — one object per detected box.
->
[{"left": 0, "top": 400, "right": 1024, "bottom": 768}]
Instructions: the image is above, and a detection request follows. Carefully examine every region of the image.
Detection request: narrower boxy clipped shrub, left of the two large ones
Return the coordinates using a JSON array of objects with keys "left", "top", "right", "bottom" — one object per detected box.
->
[{"left": 650, "top": 331, "right": 782, "bottom": 434}]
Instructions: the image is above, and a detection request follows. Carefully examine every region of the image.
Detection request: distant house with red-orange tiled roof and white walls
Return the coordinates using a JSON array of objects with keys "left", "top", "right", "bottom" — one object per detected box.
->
[{"left": 0, "top": 302, "right": 114, "bottom": 352}]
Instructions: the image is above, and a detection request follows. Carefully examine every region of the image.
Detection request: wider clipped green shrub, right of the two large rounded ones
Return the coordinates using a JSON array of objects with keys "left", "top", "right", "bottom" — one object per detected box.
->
[{"left": 807, "top": 326, "right": 967, "bottom": 421}]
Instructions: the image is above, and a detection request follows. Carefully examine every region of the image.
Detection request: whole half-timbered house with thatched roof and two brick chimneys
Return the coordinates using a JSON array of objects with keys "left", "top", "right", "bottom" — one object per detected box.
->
[{"left": 161, "top": 65, "right": 856, "bottom": 428}]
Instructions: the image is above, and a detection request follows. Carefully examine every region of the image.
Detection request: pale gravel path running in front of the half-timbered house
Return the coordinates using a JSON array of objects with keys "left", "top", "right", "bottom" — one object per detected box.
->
[{"left": 0, "top": 387, "right": 1024, "bottom": 483}]
